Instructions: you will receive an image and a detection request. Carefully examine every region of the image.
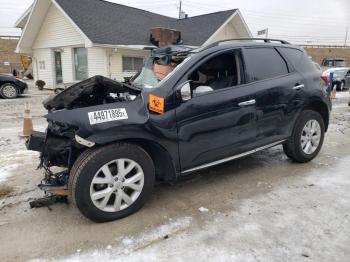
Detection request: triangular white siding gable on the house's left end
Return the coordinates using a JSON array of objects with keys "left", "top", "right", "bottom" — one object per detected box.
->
[{"left": 33, "top": 4, "right": 85, "bottom": 49}]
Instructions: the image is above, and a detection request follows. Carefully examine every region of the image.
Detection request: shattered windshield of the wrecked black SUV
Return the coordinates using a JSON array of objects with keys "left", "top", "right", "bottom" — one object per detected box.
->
[{"left": 132, "top": 56, "right": 191, "bottom": 88}]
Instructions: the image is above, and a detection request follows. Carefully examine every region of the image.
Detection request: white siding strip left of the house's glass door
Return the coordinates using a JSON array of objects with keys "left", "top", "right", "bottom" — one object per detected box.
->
[{"left": 33, "top": 48, "right": 54, "bottom": 88}]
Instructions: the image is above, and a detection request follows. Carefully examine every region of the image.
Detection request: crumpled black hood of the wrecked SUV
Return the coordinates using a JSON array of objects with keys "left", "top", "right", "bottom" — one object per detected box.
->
[{"left": 43, "top": 76, "right": 141, "bottom": 111}]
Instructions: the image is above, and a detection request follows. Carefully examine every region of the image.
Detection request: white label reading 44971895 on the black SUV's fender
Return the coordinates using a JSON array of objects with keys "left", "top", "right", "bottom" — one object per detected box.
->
[{"left": 88, "top": 108, "right": 128, "bottom": 125}]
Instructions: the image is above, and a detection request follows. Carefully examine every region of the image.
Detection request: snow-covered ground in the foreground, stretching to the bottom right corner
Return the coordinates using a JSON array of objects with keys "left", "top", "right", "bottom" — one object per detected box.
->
[{"left": 30, "top": 156, "right": 350, "bottom": 262}]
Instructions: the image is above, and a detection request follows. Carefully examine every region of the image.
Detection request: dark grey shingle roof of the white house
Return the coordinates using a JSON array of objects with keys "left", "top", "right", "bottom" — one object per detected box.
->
[{"left": 56, "top": 0, "right": 236, "bottom": 46}]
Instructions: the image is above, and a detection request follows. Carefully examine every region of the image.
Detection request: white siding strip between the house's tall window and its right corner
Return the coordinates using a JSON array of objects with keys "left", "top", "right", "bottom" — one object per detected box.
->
[{"left": 87, "top": 47, "right": 108, "bottom": 77}]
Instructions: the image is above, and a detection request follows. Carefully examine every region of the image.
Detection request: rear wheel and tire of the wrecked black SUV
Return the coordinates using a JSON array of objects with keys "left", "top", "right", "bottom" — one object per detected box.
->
[{"left": 283, "top": 110, "right": 325, "bottom": 163}]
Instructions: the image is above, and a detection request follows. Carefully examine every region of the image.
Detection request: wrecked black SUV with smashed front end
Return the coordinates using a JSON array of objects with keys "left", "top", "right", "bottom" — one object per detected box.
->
[{"left": 27, "top": 39, "right": 331, "bottom": 222}]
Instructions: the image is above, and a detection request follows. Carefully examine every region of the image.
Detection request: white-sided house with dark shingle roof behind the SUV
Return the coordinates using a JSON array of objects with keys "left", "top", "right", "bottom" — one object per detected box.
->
[{"left": 16, "top": 0, "right": 251, "bottom": 88}]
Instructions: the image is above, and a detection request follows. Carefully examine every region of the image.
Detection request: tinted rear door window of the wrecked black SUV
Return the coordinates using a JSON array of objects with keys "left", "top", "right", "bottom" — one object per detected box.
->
[{"left": 245, "top": 47, "right": 288, "bottom": 81}]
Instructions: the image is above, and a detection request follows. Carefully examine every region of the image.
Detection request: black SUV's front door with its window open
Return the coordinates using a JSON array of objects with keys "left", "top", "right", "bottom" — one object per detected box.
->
[{"left": 176, "top": 50, "right": 256, "bottom": 173}]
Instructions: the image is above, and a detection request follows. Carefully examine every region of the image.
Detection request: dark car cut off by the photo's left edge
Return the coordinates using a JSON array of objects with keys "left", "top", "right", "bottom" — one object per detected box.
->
[{"left": 0, "top": 75, "right": 28, "bottom": 99}]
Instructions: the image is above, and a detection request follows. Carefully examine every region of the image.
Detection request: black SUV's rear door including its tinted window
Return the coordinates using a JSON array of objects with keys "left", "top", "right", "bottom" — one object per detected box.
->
[{"left": 244, "top": 46, "right": 304, "bottom": 145}]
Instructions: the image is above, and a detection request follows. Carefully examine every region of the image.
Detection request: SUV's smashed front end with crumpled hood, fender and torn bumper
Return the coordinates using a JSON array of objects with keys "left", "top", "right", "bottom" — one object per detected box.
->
[{"left": 26, "top": 76, "right": 147, "bottom": 203}]
